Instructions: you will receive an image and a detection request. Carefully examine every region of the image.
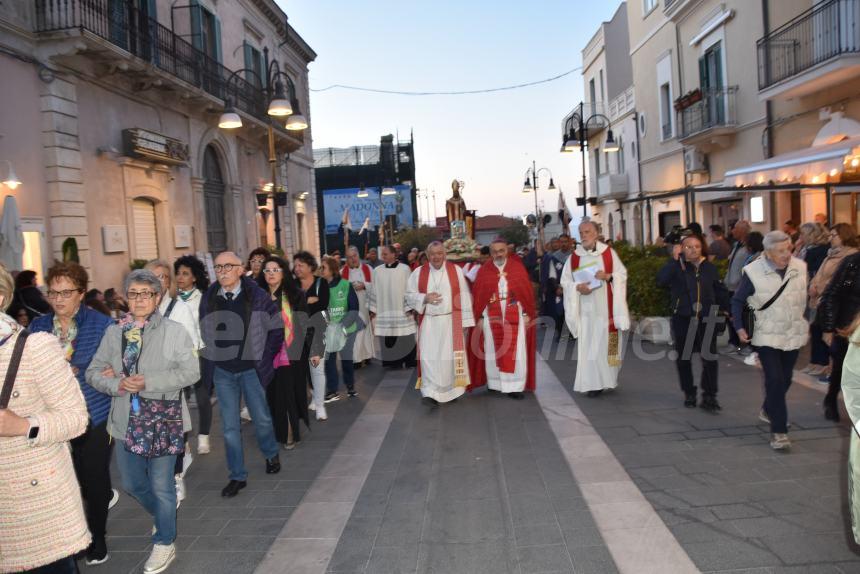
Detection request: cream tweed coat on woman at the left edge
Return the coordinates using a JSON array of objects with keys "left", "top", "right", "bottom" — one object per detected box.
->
[{"left": 0, "top": 333, "right": 90, "bottom": 572}]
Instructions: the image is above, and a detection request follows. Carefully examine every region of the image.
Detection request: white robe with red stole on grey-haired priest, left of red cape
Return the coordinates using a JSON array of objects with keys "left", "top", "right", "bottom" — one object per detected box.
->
[{"left": 406, "top": 261, "right": 475, "bottom": 403}]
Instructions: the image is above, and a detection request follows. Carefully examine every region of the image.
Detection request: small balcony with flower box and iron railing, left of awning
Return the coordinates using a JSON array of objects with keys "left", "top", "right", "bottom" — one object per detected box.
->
[{"left": 676, "top": 86, "right": 738, "bottom": 145}]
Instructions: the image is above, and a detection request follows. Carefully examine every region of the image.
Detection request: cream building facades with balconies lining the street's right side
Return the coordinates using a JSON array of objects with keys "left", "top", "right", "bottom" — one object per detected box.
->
[{"left": 572, "top": 0, "right": 860, "bottom": 242}]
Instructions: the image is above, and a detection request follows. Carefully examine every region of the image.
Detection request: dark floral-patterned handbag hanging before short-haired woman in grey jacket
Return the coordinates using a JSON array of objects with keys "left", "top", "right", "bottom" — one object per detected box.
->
[{"left": 122, "top": 328, "right": 185, "bottom": 458}]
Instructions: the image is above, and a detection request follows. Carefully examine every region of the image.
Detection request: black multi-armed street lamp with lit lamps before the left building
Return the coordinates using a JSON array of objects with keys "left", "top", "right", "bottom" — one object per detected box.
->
[{"left": 218, "top": 48, "right": 308, "bottom": 249}]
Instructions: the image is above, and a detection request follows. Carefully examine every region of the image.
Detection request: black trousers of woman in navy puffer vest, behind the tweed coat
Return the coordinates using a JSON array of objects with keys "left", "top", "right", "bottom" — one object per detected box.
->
[{"left": 72, "top": 421, "right": 113, "bottom": 539}]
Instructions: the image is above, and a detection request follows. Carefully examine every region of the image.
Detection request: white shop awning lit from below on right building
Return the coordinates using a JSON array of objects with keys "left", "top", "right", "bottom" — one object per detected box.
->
[{"left": 723, "top": 137, "right": 860, "bottom": 187}]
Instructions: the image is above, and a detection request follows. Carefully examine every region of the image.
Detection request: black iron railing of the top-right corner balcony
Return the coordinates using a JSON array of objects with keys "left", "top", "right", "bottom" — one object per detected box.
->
[{"left": 757, "top": 0, "right": 860, "bottom": 90}]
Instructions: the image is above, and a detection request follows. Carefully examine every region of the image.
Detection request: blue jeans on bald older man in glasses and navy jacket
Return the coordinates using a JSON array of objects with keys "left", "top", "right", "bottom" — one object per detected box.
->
[{"left": 212, "top": 367, "right": 278, "bottom": 480}]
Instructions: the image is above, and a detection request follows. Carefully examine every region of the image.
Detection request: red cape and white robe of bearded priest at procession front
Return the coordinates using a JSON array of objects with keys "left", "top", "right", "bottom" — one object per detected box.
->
[{"left": 469, "top": 255, "right": 536, "bottom": 393}]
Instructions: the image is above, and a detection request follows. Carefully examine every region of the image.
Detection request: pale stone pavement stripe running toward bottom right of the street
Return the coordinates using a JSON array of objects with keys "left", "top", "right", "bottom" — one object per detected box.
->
[{"left": 536, "top": 356, "right": 699, "bottom": 574}]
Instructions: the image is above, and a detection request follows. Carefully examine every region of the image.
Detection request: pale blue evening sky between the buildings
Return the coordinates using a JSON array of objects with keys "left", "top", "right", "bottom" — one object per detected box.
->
[{"left": 278, "top": 0, "right": 620, "bottom": 230}]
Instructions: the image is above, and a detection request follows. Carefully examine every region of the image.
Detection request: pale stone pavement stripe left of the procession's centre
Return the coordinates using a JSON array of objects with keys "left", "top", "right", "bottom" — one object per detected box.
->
[{"left": 254, "top": 370, "right": 412, "bottom": 574}]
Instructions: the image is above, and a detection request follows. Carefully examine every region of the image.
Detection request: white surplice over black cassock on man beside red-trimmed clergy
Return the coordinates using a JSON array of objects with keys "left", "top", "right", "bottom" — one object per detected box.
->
[{"left": 367, "top": 261, "right": 417, "bottom": 367}]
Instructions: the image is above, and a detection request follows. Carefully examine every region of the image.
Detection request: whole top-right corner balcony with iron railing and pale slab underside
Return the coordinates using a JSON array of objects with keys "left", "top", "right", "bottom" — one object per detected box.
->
[{"left": 757, "top": 0, "right": 860, "bottom": 98}]
